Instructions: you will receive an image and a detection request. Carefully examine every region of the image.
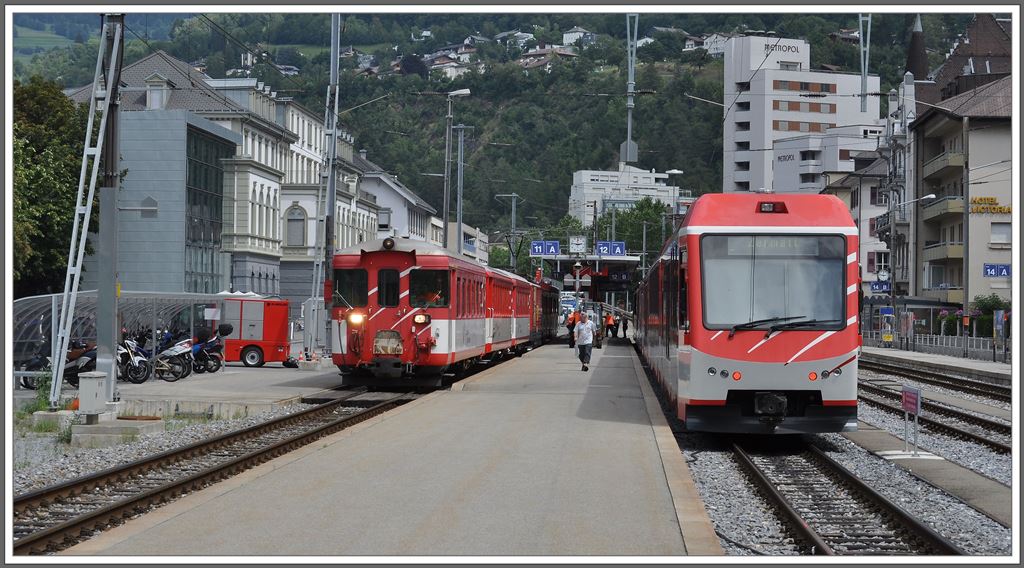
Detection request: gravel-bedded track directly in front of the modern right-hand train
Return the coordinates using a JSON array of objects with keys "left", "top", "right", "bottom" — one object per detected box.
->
[{"left": 733, "top": 444, "right": 964, "bottom": 556}]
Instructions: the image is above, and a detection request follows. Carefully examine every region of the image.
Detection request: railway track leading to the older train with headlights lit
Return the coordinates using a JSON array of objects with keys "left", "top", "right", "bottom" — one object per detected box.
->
[{"left": 12, "top": 392, "right": 410, "bottom": 555}]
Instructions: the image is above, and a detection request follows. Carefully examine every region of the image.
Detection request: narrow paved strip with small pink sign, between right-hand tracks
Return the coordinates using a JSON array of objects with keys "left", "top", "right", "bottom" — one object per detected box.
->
[{"left": 843, "top": 422, "right": 1014, "bottom": 527}]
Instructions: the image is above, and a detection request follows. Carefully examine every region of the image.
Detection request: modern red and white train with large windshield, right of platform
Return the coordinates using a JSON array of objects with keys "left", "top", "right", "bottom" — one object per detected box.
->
[{"left": 637, "top": 192, "right": 860, "bottom": 434}]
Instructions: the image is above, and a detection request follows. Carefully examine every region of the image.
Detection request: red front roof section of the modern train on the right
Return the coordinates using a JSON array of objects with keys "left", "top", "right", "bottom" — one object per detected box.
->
[{"left": 683, "top": 192, "right": 856, "bottom": 231}]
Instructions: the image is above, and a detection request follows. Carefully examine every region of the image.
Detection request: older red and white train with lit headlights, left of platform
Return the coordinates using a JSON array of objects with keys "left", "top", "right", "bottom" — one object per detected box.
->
[{"left": 325, "top": 237, "right": 558, "bottom": 386}]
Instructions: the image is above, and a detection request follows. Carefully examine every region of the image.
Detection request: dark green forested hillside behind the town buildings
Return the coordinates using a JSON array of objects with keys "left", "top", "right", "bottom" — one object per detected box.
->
[{"left": 14, "top": 13, "right": 971, "bottom": 230}]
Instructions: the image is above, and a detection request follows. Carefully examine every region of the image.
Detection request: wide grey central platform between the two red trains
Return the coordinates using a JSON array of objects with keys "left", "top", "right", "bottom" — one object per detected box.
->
[{"left": 65, "top": 340, "right": 722, "bottom": 556}]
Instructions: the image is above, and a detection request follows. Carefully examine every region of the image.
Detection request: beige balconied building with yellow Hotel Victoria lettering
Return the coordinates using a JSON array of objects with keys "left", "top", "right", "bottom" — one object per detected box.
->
[{"left": 910, "top": 76, "right": 1014, "bottom": 304}]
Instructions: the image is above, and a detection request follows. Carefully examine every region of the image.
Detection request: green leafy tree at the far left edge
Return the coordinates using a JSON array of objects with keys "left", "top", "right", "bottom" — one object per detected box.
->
[{"left": 12, "top": 78, "right": 90, "bottom": 297}]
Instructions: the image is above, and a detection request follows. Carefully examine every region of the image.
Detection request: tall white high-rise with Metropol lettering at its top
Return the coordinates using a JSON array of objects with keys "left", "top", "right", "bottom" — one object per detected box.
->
[{"left": 722, "top": 36, "right": 880, "bottom": 191}]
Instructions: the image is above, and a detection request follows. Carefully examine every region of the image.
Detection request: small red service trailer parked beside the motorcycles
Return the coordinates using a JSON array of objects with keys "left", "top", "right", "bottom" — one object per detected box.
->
[{"left": 221, "top": 298, "right": 291, "bottom": 366}]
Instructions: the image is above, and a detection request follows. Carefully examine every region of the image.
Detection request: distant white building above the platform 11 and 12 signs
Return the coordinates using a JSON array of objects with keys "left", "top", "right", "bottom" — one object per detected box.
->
[{"left": 568, "top": 163, "right": 680, "bottom": 226}]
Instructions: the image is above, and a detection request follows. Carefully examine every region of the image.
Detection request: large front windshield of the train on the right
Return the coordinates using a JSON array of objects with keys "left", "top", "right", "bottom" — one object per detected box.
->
[{"left": 700, "top": 234, "right": 846, "bottom": 330}]
